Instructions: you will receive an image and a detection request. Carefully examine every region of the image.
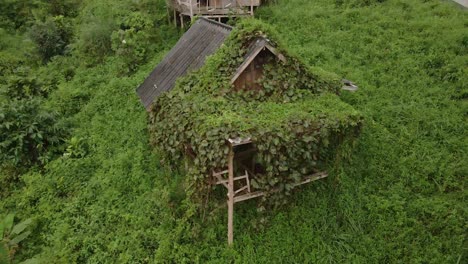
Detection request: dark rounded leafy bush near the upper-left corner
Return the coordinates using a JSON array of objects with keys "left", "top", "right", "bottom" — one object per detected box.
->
[{"left": 30, "top": 16, "right": 72, "bottom": 62}]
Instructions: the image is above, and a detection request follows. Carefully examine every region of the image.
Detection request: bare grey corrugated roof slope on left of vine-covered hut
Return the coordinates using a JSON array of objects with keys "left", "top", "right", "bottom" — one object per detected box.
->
[{"left": 137, "top": 17, "right": 232, "bottom": 110}]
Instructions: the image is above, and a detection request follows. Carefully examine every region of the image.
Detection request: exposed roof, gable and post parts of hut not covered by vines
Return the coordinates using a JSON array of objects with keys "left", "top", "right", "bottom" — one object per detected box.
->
[{"left": 137, "top": 17, "right": 357, "bottom": 244}]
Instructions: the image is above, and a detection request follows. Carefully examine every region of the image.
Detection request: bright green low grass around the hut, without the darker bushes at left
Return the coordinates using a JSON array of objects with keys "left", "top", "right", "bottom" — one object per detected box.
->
[{"left": 0, "top": 0, "right": 468, "bottom": 263}]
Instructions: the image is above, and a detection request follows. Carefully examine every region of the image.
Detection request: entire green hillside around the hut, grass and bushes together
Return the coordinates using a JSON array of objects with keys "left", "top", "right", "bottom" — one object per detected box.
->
[{"left": 0, "top": 0, "right": 468, "bottom": 263}]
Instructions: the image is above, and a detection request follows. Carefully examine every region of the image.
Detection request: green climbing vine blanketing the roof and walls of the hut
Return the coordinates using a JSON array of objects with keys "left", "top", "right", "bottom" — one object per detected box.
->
[{"left": 150, "top": 20, "right": 362, "bottom": 206}]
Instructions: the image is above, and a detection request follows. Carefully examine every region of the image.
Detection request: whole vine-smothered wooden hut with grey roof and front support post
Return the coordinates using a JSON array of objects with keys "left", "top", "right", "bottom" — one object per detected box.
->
[{"left": 137, "top": 18, "right": 362, "bottom": 243}]
